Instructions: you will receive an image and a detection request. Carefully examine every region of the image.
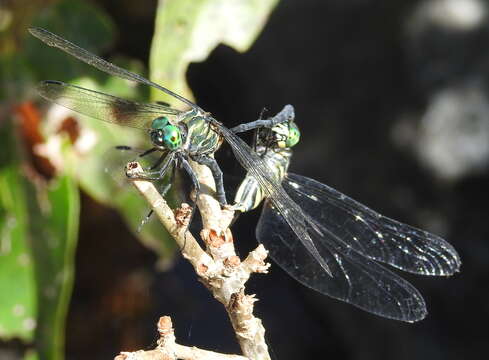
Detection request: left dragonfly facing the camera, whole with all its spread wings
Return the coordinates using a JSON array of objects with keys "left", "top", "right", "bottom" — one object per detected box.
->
[{"left": 29, "top": 28, "right": 331, "bottom": 274}]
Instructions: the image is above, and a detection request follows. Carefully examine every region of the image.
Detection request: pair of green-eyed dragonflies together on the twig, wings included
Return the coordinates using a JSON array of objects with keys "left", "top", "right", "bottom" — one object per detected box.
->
[{"left": 30, "top": 28, "right": 460, "bottom": 322}]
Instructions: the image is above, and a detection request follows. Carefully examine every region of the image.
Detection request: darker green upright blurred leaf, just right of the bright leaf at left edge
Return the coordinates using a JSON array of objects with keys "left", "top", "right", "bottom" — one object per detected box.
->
[{"left": 29, "top": 175, "right": 80, "bottom": 360}]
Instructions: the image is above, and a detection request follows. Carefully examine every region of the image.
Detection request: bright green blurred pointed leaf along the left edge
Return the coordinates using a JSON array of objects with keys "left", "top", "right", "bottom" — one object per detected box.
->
[{"left": 0, "top": 126, "right": 36, "bottom": 341}]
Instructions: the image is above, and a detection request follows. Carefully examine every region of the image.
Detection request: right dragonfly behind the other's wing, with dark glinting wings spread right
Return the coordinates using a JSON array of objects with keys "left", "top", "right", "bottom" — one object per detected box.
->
[{"left": 233, "top": 105, "right": 461, "bottom": 322}]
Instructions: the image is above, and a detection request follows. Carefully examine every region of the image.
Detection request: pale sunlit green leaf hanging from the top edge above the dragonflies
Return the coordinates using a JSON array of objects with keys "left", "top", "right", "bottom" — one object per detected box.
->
[{"left": 150, "top": 0, "right": 278, "bottom": 105}]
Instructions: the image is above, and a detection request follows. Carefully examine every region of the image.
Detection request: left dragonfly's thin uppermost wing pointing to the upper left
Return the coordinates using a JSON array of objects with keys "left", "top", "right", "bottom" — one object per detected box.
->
[{"left": 29, "top": 28, "right": 200, "bottom": 109}]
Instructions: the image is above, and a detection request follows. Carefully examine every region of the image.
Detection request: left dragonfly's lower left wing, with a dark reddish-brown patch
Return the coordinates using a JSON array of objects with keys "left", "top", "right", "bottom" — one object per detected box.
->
[{"left": 38, "top": 80, "right": 181, "bottom": 129}]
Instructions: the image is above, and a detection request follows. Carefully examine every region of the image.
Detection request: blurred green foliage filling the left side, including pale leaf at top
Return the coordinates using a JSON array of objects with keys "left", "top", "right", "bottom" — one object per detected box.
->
[{"left": 0, "top": 0, "right": 277, "bottom": 360}]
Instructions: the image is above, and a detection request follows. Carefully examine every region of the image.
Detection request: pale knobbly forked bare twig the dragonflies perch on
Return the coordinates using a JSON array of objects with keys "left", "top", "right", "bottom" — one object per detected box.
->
[{"left": 116, "top": 163, "right": 270, "bottom": 360}]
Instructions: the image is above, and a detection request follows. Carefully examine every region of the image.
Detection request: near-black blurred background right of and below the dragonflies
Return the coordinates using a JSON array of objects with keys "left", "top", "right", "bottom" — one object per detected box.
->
[{"left": 67, "top": 0, "right": 489, "bottom": 360}]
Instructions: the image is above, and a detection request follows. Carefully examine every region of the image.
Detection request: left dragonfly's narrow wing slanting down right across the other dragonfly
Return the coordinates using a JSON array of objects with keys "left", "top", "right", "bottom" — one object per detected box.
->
[{"left": 213, "top": 124, "right": 331, "bottom": 274}]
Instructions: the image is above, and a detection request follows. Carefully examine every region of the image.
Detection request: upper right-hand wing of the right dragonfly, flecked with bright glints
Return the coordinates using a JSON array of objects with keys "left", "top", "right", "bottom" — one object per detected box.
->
[{"left": 283, "top": 173, "right": 461, "bottom": 276}]
